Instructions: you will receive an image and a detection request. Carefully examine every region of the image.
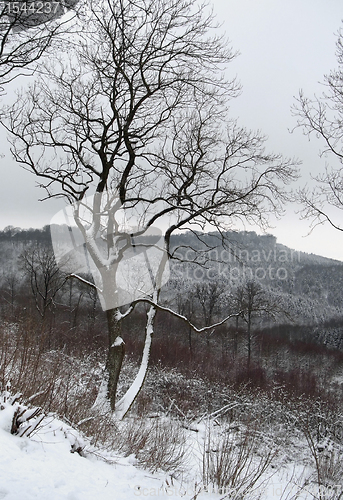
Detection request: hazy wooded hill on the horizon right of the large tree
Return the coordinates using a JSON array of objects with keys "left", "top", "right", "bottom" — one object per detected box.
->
[{"left": 172, "top": 231, "right": 343, "bottom": 294}]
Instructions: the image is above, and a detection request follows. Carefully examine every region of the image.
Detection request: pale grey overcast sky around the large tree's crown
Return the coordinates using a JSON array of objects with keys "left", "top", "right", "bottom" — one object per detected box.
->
[{"left": 0, "top": 0, "right": 343, "bottom": 260}]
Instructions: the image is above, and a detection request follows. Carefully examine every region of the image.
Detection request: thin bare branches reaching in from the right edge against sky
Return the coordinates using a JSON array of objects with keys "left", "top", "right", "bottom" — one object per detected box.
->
[{"left": 293, "top": 25, "right": 343, "bottom": 231}]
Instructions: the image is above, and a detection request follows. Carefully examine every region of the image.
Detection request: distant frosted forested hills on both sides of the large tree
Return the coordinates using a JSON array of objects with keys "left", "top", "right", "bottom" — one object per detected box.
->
[{"left": 0, "top": 226, "right": 343, "bottom": 328}]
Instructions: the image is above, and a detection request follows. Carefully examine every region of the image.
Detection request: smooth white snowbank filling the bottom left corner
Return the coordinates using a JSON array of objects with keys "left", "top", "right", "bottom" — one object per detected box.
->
[{"left": 0, "top": 406, "right": 189, "bottom": 500}]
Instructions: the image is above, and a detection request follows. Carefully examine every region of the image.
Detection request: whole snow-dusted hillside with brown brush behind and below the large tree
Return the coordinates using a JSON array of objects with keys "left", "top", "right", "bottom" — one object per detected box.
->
[{"left": 0, "top": 227, "right": 343, "bottom": 500}]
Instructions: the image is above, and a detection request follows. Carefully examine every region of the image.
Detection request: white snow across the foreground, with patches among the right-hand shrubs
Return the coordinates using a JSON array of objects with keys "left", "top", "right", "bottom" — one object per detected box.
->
[{"left": 0, "top": 394, "right": 334, "bottom": 500}]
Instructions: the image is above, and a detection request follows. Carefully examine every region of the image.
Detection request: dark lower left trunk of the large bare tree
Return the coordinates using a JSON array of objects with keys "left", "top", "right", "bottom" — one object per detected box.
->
[{"left": 106, "top": 309, "right": 125, "bottom": 411}]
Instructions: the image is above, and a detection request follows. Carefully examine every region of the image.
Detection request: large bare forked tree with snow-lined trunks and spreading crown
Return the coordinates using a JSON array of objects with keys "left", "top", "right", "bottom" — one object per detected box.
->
[{"left": 3, "top": 0, "right": 296, "bottom": 416}]
